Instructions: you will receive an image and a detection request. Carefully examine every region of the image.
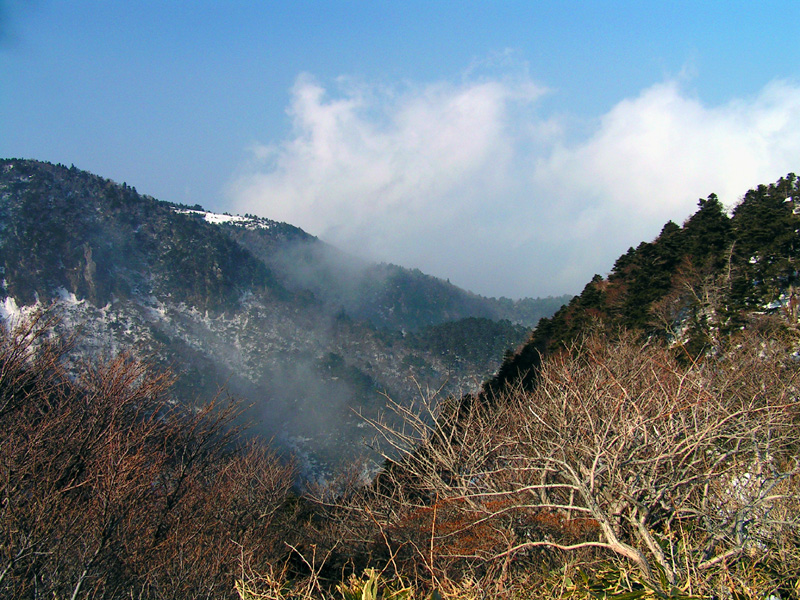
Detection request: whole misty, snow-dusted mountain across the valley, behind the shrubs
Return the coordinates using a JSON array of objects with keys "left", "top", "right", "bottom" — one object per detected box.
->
[{"left": 0, "top": 160, "right": 566, "bottom": 476}]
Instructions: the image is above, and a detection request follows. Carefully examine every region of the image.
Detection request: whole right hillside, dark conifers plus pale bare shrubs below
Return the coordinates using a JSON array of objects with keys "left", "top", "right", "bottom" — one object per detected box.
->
[{"left": 348, "top": 174, "right": 800, "bottom": 598}]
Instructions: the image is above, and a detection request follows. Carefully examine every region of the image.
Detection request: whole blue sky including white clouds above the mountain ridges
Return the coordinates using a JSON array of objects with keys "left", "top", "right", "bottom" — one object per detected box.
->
[{"left": 0, "top": 0, "right": 800, "bottom": 297}]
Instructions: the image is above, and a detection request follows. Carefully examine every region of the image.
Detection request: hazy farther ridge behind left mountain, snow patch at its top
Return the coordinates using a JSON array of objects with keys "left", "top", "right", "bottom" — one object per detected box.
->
[{"left": 212, "top": 206, "right": 570, "bottom": 331}]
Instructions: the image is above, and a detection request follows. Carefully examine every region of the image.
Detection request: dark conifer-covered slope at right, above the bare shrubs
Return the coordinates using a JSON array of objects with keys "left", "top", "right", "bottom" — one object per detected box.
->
[{"left": 483, "top": 173, "right": 800, "bottom": 395}]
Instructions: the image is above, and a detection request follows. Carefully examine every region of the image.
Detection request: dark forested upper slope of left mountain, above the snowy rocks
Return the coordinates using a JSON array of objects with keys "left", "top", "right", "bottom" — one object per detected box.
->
[{"left": 0, "top": 161, "right": 285, "bottom": 310}]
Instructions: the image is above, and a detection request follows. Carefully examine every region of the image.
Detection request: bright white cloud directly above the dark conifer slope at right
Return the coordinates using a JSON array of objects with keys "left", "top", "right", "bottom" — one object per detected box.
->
[{"left": 532, "top": 81, "right": 800, "bottom": 289}]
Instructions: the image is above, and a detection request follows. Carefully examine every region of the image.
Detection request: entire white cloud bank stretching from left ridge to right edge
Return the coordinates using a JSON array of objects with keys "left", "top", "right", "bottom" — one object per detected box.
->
[{"left": 231, "top": 68, "right": 800, "bottom": 296}]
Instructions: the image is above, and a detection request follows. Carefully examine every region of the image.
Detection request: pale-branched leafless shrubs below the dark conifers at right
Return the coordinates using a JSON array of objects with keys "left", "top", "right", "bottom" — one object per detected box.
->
[{"left": 354, "top": 324, "right": 800, "bottom": 593}]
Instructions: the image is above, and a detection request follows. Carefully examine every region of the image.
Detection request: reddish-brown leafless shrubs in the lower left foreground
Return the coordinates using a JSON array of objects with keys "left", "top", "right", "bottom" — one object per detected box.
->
[{"left": 0, "top": 318, "right": 294, "bottom": 599}]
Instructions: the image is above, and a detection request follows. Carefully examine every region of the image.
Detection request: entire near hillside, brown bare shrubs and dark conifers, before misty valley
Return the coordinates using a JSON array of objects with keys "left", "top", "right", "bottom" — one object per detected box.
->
[{"left": 0, "top": 175, "right": 800, "bottom": 600}]
